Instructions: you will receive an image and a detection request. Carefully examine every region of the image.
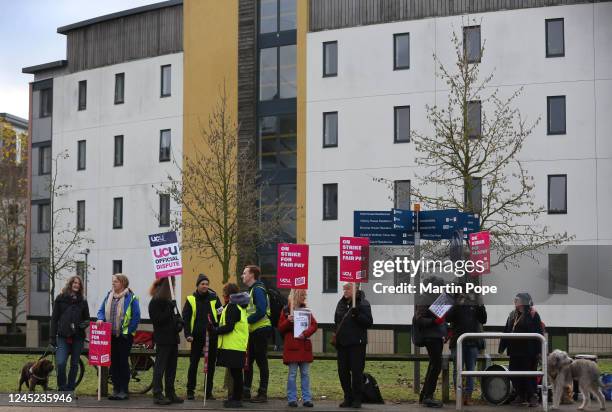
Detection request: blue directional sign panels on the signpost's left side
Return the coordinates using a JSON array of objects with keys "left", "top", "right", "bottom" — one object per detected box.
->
[{"left": 353, "top": 210, "right": 414, "bottom": 245}]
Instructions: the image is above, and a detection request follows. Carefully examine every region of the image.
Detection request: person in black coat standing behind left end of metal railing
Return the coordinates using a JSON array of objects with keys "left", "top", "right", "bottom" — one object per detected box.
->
[{"left": 446, "top": 293, "right": 487, "bottom": 406}]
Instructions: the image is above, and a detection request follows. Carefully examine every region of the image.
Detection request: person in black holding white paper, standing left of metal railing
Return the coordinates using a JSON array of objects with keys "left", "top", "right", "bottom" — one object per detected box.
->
[{"left": 412, "top": 276, "right": 447, "bottom": 408}]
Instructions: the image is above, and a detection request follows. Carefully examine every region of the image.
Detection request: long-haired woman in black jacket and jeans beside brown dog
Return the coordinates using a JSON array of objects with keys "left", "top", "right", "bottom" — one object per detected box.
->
[{"left": 50, "top": 276, "right": 89, "bottom": 391}]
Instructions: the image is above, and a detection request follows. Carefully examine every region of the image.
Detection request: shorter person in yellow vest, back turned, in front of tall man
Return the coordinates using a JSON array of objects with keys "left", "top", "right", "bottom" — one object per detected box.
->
[{"left": 212, "top": 283, "right": 249, "bottom": 408}]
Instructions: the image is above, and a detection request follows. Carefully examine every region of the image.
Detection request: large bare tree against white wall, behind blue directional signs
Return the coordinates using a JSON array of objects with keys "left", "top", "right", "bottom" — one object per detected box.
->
[{"left": 374, "top": 25, "right": 571, "bottom": 266}]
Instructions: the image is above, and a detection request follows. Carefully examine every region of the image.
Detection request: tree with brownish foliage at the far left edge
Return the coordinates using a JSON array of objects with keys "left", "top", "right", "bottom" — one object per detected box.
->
[{"left": 0, "top": 119, "right": 28, "bottom": 333}]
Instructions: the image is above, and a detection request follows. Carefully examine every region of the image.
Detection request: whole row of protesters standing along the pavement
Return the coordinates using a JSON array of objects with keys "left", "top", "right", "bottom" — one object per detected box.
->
[{"left": 50, "top": 265, "right": 542, "bottom": 408}]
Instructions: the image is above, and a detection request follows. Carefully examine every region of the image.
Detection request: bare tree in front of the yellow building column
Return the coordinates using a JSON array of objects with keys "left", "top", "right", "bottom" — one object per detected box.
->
[{"left": 156, "top": 85, "right": 290, "bottom": 283}]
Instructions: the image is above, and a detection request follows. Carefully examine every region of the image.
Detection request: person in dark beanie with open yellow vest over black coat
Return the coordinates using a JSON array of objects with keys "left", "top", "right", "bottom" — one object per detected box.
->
[{"left": 183, "top": 273, "right": 223, "bottom": 400}]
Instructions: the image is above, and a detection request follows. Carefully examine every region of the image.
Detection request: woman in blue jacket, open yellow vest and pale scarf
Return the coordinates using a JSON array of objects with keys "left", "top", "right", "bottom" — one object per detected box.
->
[{"left": 97, "top": 273, "right": 140, "bottom": 400}]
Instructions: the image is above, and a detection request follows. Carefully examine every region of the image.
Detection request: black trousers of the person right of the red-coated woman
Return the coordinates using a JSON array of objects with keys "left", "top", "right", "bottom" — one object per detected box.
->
[{"left": 336, "top": 345, "right": 366, "bottom": 402}]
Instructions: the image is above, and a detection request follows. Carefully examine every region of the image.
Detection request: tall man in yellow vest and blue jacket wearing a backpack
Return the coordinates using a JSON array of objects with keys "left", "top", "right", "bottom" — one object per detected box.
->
[{"left": 242, "top": 265, "right": 272, "bottom": 402}]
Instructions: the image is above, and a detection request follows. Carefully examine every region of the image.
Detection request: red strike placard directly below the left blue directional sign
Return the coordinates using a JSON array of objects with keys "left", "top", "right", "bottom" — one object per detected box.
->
[{"left": 340, "top": 237, "right": 370, "bottom": 283}]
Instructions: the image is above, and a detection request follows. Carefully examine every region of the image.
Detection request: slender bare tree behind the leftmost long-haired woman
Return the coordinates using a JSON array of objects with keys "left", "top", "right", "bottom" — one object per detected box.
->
[{"left": 47, "top": 151, "right": 94, "bottom": 308}]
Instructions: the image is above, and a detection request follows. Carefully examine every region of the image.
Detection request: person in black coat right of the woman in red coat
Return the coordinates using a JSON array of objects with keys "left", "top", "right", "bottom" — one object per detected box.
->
[{"left": 334, "top": 283, "right": 374, "bottom": 408}]
